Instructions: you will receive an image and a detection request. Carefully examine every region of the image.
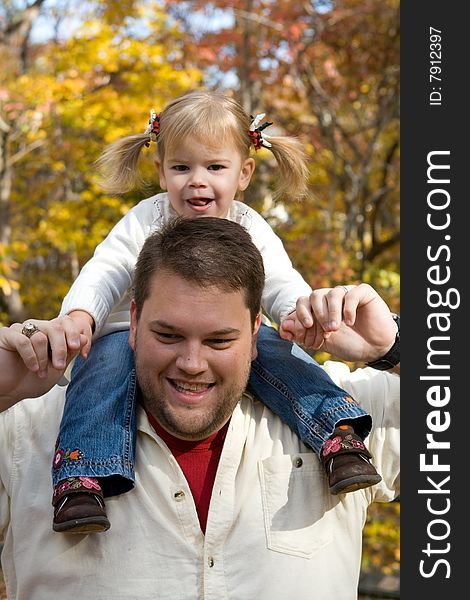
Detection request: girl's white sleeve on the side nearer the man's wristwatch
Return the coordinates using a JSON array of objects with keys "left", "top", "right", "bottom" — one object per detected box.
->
[{"left": 247, "top": 210, "right": 312, "bottom": 325}]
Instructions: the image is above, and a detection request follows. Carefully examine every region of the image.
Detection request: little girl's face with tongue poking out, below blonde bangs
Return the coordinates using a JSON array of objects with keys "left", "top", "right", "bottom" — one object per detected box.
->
[{"left": 159, "top": 137, "right": 255, "bottom": 218}]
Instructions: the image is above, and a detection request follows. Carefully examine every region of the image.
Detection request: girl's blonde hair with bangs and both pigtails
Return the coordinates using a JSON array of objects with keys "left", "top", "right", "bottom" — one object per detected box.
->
[{"left": 97, "top": 91, "right": 308, "bottom": 199}]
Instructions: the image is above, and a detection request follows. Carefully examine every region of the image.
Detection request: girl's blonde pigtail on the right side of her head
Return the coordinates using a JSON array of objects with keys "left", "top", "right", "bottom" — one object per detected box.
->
[{"left": 266, "top": 136, "right": 309, "bottom": 200}]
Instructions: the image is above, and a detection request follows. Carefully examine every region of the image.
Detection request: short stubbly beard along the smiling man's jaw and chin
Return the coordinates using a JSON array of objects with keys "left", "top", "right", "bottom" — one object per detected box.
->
[{"left": 135, "top": 339, "right": 251, "bottom": 440}]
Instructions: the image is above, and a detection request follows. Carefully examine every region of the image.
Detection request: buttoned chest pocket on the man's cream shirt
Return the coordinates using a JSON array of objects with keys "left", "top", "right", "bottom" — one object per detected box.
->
[{"left": 258, "top": 453, "right": 333, "bottom": 558}]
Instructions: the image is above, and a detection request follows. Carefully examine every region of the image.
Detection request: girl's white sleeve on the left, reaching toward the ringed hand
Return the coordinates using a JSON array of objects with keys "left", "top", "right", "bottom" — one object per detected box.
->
[{"left": 60, "top": 198, "right": 154, "bottom": 335}]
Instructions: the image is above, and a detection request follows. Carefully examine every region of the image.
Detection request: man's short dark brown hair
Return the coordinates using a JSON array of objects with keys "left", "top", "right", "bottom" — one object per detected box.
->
[{"left": 134, "top": 217, "right": 265, "bottom": 324}]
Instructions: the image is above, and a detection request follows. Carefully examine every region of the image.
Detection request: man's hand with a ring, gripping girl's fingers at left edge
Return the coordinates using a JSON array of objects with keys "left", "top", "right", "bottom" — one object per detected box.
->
[{"left": 0, "top": 317, "right": 87, "bottom": 411}]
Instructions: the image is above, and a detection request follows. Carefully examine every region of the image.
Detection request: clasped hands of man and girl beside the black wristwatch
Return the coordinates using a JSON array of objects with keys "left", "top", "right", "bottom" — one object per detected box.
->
[{"left": 280, "top": 283, "right": 397, "bottom": 362}]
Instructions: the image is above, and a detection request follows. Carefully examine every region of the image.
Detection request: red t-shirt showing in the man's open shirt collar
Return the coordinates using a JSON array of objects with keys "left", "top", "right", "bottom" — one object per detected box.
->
[{"left": 147, "top": 412, "right": 230, "bottom": 533}]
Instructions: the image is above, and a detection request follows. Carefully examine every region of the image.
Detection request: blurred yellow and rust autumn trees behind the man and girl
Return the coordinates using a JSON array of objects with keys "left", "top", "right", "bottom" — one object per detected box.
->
[{"left": 0, "top": 0, "right": 400, "bottom": 592}]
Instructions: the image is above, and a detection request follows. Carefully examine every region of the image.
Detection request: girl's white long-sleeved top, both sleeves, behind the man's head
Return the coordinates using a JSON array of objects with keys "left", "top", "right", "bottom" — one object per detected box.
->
[{"left": 60, "top": 193, "right": 312, "bottom": 337}]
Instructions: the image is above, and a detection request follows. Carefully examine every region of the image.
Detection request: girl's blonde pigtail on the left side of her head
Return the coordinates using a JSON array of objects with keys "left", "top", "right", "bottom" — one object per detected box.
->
[{"left": 95, "top": 133, "right": 150, "bottom": 195}]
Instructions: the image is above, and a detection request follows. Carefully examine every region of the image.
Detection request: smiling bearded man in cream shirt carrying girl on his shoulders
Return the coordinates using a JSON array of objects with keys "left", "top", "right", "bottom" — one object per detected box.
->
[{"left": 0, "top": 218, "right": 399, "bottom": 600}]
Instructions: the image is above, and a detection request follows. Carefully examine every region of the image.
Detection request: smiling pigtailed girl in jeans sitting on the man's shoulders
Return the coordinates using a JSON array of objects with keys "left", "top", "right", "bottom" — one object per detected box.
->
[{"left": 52, "top": 92, "right": 381, "bottom": 533}]
